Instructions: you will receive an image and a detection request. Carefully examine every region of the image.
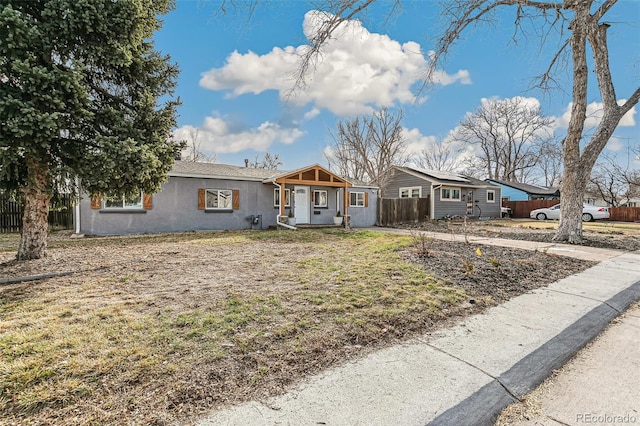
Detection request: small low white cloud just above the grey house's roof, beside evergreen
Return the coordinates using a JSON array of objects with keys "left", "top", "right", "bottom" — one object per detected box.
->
[{"left": 173, "top": 117, "right": 304, "bottom": 154}]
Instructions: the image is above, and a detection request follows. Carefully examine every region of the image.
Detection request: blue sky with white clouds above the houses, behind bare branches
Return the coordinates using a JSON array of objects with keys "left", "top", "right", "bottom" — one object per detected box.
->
[{"left": 156, "top": 0, "right": 640, "bottom": 175}]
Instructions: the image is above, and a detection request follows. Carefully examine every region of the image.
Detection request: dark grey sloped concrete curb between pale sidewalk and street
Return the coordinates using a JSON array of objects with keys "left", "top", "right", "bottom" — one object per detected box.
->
[{"left": 427, "top": 281, "right": 640, "bottom": 426}]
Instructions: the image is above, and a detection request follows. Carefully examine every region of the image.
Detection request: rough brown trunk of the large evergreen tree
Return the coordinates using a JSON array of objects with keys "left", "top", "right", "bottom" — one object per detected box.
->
[{"left": 16, "top": 159, "right": 51, "bottom": 260}]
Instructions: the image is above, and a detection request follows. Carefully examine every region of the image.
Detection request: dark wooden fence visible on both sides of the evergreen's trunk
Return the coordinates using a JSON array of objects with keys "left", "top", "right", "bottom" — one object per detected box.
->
[{"left": 0, "top": 194, "right": 73, "bottom": 233}]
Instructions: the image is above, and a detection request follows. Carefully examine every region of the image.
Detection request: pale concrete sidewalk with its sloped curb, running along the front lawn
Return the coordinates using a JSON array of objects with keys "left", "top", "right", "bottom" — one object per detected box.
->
[{"left": 199, "top": 234, "right": 640, "bottom": 426}]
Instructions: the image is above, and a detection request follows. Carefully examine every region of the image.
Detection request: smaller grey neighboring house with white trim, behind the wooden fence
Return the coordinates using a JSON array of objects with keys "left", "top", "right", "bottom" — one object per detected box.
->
[{"left": 382, "top": 166, "right": 501, "bottom": 219}]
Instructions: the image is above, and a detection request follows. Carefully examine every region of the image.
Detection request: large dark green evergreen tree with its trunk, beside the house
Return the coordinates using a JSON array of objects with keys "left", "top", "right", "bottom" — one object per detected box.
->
[{"left": 0, "top": 0, "right": 180, "bottom": 259}]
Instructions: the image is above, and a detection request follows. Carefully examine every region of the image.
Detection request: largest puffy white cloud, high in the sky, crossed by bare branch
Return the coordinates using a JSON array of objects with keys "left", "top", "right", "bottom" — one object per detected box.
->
[{"left": 200, "top": 11, "right": 471, "bottom": 116}]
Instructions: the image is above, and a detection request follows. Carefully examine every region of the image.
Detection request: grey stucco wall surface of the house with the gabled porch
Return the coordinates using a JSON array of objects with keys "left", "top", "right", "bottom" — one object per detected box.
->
[{"left": 80, "top": 177, "right": 376, "bottom": 235}]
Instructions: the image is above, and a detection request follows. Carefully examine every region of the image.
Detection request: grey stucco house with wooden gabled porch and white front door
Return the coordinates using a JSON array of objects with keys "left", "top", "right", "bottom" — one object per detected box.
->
[{"left": 76, "top": 161, "right": 378, "bottom": 235}]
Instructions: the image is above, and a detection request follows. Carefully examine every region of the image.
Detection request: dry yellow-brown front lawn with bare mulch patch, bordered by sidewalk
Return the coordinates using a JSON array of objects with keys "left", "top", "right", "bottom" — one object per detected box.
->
[{"left": 0, "top": 230, "right": 608, "bottom": 425}]
